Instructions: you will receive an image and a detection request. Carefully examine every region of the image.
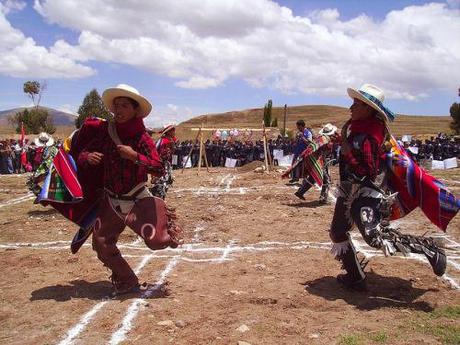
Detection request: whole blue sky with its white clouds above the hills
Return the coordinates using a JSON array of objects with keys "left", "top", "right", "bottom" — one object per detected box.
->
[{"left": 0, "top": 0, "right": 460, "bottom": 125}]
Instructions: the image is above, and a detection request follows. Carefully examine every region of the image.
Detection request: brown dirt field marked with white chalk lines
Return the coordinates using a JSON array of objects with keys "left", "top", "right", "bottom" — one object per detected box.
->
[{"left": 0, "top": 169, "right": 460, "bottom": 344}]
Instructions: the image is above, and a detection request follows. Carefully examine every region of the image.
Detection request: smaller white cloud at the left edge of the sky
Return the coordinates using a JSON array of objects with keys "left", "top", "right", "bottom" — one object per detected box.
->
[{"left": 0, "top": 1, "right": 95, "bottom": 78}]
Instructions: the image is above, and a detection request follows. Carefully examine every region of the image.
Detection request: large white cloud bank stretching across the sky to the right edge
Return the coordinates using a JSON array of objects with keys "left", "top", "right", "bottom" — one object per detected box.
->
[{"left": 8, "top": 0, "right": 460, "bottom": 100}]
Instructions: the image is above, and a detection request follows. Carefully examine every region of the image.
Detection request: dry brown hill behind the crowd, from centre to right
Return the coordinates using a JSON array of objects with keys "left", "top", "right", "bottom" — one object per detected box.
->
[{"left": 176, "top": 105, "right": 452, "bottom": 139}]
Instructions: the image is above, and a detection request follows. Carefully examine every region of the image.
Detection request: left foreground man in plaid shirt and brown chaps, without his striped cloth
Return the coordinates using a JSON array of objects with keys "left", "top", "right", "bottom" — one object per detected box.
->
[{"left": 75, "top": 84, "right": 181, "bottom": 294}]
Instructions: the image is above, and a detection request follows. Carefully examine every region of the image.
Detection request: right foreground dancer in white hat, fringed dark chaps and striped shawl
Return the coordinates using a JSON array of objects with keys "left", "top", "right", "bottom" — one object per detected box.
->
[{"left": 330, "top": 84, "right": 460, "bottom": 290}]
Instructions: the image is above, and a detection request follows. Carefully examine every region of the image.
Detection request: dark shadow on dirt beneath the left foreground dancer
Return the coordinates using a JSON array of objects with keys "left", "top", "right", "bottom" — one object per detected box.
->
[{"left": 30, "top": 280, "right": 170, "bottom": 302}]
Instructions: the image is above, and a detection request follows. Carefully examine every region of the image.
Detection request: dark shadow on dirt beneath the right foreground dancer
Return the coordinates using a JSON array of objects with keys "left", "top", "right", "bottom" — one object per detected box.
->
[{"left": 302, "top": 272, "right": 438, "bottom": 312}]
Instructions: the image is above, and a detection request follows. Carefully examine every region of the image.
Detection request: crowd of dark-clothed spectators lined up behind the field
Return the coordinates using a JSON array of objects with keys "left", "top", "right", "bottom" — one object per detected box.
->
[{"left": 0, "top": 133, "right": 460, "bottom": 174}]
